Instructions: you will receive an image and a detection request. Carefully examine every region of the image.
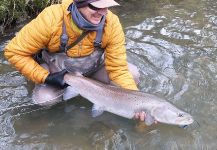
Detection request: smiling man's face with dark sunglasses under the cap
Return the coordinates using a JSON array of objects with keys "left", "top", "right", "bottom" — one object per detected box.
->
[{"left": 78, "top": 4, "right": 108, "bottom": 25}]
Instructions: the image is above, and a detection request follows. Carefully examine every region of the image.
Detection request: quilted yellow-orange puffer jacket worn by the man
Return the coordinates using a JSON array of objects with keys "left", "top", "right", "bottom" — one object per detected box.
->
[{"left": 4, "top": 0, "right": 137, "bottom": 90}]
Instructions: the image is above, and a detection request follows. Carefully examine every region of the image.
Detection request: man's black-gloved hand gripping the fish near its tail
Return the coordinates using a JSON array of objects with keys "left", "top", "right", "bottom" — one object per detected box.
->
[{"left": 45, "top": 69, "right": 67, "bottom": 88}]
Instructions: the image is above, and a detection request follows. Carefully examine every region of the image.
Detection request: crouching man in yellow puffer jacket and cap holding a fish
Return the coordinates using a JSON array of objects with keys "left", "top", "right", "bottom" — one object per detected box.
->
[{"left": 4, "top": 0, "right": 145, "bottom": 120}]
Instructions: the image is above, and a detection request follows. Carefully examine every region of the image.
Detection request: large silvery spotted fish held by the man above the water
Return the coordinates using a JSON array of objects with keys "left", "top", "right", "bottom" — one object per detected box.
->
[{"left": 64, "top": 73, "right": 193, "bottom": 126}]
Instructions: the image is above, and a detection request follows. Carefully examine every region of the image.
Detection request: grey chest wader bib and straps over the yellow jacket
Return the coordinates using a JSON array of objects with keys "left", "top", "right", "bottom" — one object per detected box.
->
[{"left": 41, "top": 20, "right": 104, "bottom": 77}]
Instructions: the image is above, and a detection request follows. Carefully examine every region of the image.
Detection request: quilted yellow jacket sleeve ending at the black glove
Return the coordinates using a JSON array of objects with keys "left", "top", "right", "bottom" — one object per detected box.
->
[{"left": 4, "top": 6, "right": 52, "bottom": 83}]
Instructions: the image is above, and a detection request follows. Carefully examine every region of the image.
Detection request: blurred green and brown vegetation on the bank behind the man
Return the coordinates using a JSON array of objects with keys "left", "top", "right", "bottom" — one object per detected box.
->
[{"left": 0, "top": 0, "right": 61, "bottom": 34}]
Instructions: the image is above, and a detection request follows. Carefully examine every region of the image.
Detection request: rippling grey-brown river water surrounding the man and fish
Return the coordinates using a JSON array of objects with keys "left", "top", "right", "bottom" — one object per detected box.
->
[{"left": 0, "top": 0, "right": 217, "bottom": 150}]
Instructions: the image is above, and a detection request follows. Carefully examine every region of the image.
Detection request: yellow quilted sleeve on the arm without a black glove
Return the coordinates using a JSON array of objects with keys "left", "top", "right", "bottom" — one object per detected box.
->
[{"left": 105, "top": 15, "right": 138, "bottom": 90}]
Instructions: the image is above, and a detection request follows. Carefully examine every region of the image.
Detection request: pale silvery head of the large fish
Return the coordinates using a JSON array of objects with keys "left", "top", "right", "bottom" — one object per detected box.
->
[{"left": 152, "top": 103, "right": 194, "bottom": 126}]
